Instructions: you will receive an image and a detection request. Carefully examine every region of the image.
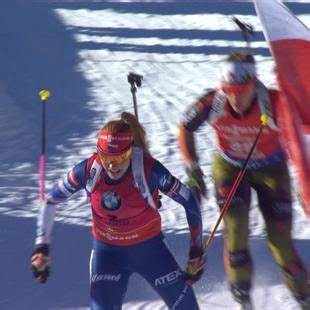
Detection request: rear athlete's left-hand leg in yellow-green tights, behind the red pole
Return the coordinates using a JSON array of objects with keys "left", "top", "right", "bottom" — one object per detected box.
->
[{"left": 213, "top": 157, "right": 253, "bottom": 303}]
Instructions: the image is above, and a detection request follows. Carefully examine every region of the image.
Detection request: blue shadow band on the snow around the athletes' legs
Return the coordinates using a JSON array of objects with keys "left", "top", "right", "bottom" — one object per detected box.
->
[{"left": 0, "top": 215, "right": 310, "bottom": 310}]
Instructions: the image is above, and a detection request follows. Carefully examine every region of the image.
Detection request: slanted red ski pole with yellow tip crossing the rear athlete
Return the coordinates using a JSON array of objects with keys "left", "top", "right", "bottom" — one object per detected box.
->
[{"left": 205, "top": 114, "right": 269, "bottom": 252}]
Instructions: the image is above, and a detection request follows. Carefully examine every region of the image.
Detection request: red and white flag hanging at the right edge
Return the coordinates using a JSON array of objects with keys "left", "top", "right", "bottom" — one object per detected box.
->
[{"left": 254, "top": 0, "right": 310, "bottom": 216}]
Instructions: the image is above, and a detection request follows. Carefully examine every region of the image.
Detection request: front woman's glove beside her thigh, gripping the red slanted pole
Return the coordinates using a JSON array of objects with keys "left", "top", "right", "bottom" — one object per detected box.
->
[{"left": 185, "top": 246, "right": 206, "bottom": 285}]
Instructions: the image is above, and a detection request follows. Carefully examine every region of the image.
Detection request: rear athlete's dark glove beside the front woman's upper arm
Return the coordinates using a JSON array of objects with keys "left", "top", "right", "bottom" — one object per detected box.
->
[{"left": 186, "top": 164, "right": 207, "bottom": 200}]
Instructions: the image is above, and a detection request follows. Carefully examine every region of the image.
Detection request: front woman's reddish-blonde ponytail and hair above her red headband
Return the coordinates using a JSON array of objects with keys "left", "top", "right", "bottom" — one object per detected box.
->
[{"left": 102, "top": 112, "right": 149, "bottom": 154}]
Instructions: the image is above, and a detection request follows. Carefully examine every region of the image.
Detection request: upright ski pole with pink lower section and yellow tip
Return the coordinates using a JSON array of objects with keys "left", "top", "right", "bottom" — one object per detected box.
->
[{"left": 39, "top": 89, "right": 51, "bottom": 204}]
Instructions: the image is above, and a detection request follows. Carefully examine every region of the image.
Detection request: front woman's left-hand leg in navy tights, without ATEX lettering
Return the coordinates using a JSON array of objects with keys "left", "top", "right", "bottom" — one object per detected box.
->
[{"left": 90, "top": 240, "right": 131, "bottom": 310}]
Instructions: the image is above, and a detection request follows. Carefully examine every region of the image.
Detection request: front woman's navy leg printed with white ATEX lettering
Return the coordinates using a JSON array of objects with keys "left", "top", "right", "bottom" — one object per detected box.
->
[{"left": 131, "top": 235, "right": 199, "bottom": 310}]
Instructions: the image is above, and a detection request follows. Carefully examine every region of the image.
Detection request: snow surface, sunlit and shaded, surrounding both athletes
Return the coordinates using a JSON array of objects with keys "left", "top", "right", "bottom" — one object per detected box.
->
[{"left": 0, "top": 0, "right": 310, "bottom": 310}]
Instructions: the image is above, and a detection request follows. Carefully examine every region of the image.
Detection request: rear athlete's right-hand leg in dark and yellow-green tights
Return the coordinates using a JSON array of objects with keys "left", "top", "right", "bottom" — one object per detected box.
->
[{"left": 252, "top": 163, "right": 310, "bottom": 309}]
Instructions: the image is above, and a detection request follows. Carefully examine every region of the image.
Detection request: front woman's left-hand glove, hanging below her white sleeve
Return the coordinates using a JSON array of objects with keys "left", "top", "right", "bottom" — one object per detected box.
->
[{"left": 31, "top": 243, "right": 50, "bottom": 283}]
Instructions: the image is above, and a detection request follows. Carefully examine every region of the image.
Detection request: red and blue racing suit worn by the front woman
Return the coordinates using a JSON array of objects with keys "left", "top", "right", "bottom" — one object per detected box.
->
[{"left": 36, "top": 154, "right": 202, "bottom": 309}]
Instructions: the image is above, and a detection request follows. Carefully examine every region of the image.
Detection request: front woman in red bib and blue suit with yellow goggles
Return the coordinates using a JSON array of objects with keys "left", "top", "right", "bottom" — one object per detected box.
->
[{"left": 32, "top": 113, "right": 205, "bottom": 310}]
